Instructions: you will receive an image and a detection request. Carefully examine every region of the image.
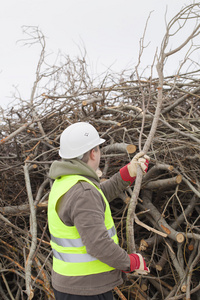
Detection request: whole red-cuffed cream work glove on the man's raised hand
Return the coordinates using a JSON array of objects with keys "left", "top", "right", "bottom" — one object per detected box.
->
[{"left": 119, "top": 152, "right": 150, "bottom": 184}]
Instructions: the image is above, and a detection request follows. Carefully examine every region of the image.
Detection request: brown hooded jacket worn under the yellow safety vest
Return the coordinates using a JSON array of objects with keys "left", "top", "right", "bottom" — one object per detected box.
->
[{"left": 50, "top": 159, "right": 130, "bottom": 295}]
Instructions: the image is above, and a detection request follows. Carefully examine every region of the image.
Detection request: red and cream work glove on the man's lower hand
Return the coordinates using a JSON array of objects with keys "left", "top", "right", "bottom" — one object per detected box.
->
[{"left": 125, "top": 253, "right": 150, "bottom": 275}]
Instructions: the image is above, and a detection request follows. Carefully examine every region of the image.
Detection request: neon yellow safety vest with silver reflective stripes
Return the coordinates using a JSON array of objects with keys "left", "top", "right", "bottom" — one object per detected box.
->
[{"left": 48, "top": 175, "right": 118, "bottom": 276}]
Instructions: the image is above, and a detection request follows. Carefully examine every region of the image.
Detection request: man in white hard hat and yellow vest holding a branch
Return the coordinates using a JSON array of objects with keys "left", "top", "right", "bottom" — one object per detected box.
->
[{"left": 48, "top": 122, "right": 149, "bottom": 300}]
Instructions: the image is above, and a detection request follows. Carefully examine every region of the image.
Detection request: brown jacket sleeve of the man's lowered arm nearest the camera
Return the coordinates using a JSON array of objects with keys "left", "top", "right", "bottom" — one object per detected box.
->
[{"left": 60, "top": 182, "right": 130, "bottom": 271}]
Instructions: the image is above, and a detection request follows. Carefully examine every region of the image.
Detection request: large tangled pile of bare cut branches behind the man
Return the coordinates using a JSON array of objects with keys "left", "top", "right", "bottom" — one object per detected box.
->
[{"left": 0, "top": 69, "right": 200, "bottom": 300}]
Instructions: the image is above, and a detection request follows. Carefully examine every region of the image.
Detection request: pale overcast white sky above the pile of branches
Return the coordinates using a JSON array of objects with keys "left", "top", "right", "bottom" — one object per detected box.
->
[{"left": 0, "top": 0, "right": 197, "bottom": 107}]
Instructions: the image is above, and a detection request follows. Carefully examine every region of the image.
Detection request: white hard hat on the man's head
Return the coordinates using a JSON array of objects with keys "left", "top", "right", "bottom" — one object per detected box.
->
[{"left": 59, "top": 122, "right": 105, "bottom": 159}]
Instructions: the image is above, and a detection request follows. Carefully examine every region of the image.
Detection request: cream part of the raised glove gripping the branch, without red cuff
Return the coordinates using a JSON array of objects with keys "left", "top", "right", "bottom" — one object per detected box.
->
[{"left": 127, "top": 151, "right": 150, "bottom": 177}]
